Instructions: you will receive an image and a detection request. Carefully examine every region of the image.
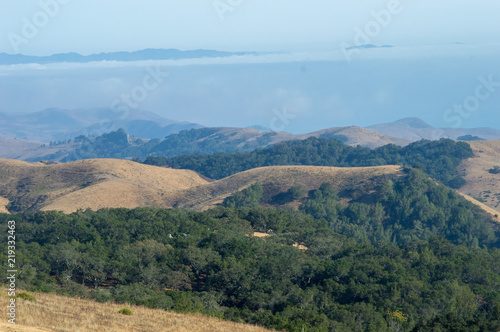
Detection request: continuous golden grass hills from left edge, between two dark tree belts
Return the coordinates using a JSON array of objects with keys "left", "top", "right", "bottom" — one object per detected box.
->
[{"left": 0, "top": 159, "right": 400, "bottom": 213}]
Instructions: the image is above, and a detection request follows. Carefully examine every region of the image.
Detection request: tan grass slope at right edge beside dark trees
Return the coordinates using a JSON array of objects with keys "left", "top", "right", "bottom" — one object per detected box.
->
[{"left": 459, "top": 140, "right": 500, "bottom": 215}]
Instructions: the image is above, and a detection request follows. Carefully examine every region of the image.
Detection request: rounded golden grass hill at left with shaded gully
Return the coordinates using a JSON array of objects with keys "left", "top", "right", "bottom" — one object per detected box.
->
[{"left": 0, "top": 159, "right": 207, "bottom": 213}]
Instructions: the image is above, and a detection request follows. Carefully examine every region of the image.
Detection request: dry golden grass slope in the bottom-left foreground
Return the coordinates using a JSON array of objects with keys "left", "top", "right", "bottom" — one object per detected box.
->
[{"left": 0, "top": 292, "right": 270, "bottom": 332}]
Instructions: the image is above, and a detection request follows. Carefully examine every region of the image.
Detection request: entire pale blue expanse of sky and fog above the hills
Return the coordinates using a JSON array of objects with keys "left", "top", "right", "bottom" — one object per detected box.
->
[{"left": 0, "top": 0, "right": 500, "bottom": 133}]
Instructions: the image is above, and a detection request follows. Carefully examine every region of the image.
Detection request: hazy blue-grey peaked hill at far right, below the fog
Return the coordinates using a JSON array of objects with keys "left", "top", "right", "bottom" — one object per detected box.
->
[{"left": 366, "top": 118, "right": 500, "bottom": 141}]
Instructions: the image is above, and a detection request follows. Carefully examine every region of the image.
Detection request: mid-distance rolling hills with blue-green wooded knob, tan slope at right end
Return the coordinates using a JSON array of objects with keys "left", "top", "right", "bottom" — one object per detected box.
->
[{"left": 0, "top": 124, "right": 410, "bottom": 162}]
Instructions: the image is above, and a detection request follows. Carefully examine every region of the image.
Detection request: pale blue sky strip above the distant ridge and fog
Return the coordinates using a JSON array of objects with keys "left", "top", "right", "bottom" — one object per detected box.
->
[{"left": 0, "top": 0, "right": 500, "bottom": 55}]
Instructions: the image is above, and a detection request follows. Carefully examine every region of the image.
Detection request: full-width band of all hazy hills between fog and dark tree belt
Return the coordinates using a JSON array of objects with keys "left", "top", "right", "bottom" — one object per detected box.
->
[{"left": 0, "top": 108, "right": 500, "bottom": 161}]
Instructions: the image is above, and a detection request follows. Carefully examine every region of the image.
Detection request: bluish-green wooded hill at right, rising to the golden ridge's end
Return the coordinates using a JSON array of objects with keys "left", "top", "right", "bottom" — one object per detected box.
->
[{"left": 300, "top": 169, "right": 500, "bottom": 248}]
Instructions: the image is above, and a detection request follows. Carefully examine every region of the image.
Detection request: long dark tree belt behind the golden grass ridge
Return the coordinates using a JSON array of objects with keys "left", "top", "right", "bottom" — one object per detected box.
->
[{"left": 156, "top": 137, "right": 473, "bottom": 184}]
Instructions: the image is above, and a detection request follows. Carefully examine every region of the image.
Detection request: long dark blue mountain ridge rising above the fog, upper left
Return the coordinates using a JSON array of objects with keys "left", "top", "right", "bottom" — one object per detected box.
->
[{"left": 0, "top": 49, "right": 257, "bottom": 65}]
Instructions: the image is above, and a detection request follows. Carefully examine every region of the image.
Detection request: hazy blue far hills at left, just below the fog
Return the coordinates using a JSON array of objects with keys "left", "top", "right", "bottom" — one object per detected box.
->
[{"left": 0, "top": 108, "right": 202, "bottom": 143}]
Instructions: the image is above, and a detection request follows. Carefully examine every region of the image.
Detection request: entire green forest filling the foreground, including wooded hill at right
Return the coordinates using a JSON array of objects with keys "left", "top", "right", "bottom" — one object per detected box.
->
[{"left": 0, "top": 170, "right": 500, "bottom": 331}]
